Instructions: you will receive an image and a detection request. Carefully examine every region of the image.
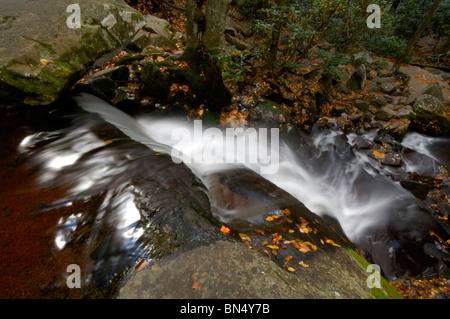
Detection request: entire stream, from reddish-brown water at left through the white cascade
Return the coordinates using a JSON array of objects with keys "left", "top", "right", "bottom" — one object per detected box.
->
[{"left": 0, "top": 94, "right": 450, "bottom": 298}]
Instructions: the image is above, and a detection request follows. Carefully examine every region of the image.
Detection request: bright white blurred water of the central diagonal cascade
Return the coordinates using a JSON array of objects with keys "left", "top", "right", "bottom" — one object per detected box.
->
[{"left": 77, "top": 95, "right": 432, "bottom": 240}]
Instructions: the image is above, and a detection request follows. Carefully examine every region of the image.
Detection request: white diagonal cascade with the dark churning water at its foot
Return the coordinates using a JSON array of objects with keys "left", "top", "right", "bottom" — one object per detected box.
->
[{"left": 77, "top": 97, "right": 450, "bottom": 277}]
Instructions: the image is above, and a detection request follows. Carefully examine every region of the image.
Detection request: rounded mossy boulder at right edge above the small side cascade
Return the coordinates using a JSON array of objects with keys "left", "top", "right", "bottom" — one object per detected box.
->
[{"left": 412, "top": 94, "right": 450, "bottom": 135}]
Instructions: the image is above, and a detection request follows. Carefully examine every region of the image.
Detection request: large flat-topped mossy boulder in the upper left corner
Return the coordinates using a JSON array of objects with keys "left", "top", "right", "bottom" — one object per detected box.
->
[{"left": 0, "top": 0, "right": 145, "bottom": 105}]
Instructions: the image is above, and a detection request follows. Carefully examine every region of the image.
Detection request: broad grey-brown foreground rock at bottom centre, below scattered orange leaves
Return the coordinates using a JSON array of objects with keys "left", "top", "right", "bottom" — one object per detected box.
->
[{"left": 118, "top": 240, "right": 392, "bottom": 299}]
